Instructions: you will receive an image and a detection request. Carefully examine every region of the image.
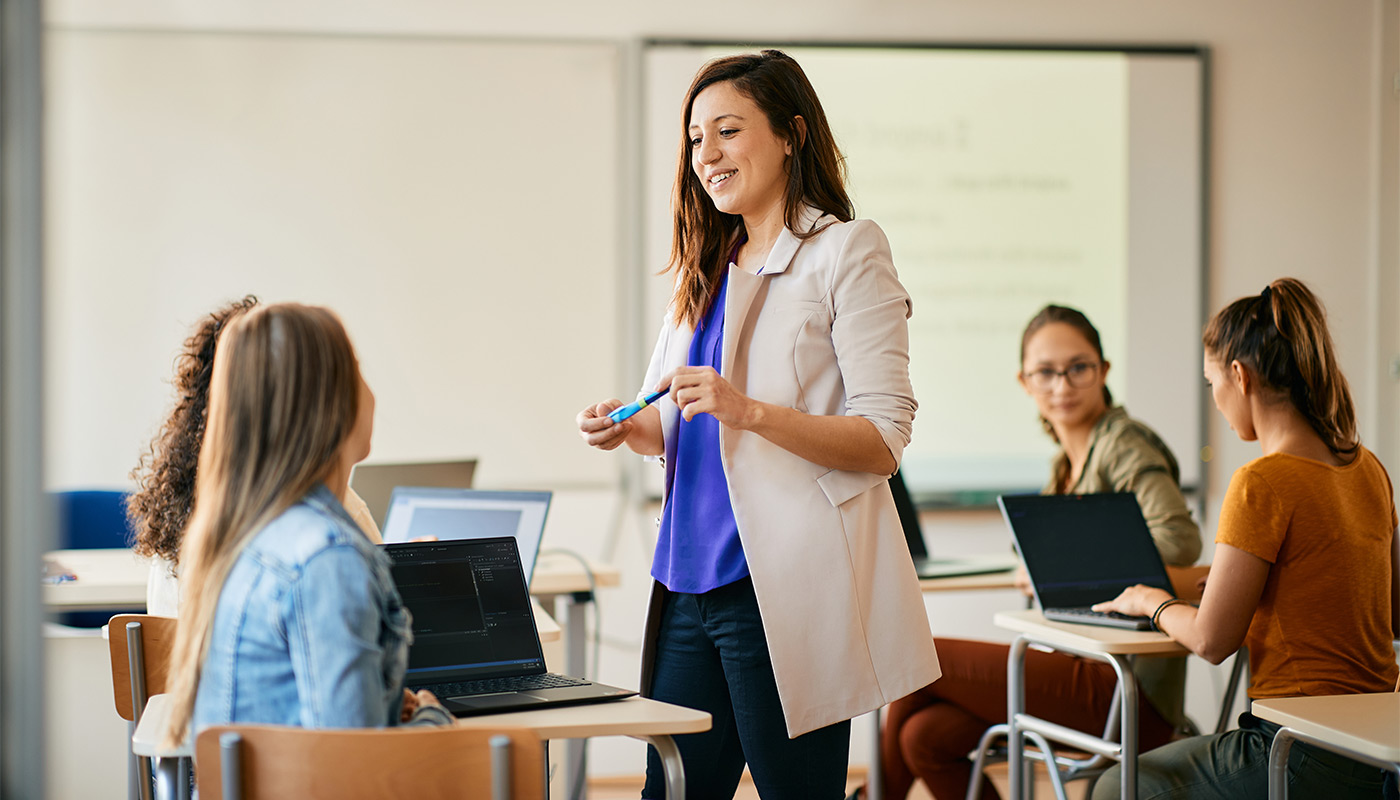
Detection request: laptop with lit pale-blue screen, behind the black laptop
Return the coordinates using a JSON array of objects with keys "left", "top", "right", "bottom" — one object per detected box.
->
[{"left": 381, "top": 486, "right": 553, "bottom": 584}]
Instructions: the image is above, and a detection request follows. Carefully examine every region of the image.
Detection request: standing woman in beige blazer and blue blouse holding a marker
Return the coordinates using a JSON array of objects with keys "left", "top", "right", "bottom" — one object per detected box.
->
[{"left": 578, "top": 50, "right": 939, "bottom": 800}]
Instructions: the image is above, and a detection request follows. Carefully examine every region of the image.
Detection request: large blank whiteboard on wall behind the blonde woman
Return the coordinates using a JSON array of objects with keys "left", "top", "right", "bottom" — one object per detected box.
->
[{"left": 46, "top": 31, "right": 631, "bottom": 488}]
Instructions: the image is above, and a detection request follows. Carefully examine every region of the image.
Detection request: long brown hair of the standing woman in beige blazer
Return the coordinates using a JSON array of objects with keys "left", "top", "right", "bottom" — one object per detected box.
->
[{"left": 666, "top": 50, "right": 855, "bottom": 328}]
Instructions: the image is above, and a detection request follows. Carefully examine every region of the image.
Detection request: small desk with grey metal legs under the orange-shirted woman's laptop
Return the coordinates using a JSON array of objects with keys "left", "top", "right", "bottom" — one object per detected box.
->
[{"left": 993, "top": 609, "right": 1187, "bottom": 800}]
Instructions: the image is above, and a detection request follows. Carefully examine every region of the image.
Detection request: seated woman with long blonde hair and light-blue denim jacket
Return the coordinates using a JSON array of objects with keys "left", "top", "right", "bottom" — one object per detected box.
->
[{"left": 168, "top": 304, "right": 451, "bottom": 743}]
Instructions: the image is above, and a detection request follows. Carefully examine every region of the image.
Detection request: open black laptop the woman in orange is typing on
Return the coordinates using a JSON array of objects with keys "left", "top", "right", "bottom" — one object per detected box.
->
[{"left": 997, "top": 492, "right": 1175, "bottom": 630}]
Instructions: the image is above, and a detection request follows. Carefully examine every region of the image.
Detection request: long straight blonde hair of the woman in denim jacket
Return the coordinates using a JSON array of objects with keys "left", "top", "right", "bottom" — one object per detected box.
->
[{"left": 167, "top": 304, "right": 360, "bottom": 745}]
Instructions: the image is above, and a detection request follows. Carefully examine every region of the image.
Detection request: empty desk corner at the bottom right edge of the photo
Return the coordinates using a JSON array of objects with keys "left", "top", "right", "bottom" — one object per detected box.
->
[{"left": 1250, "top": 692, "right": 1400, "bottom": 800}]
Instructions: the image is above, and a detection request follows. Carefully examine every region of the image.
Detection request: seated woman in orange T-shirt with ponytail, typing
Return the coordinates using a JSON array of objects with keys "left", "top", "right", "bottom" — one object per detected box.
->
[{"left": 1093, "top": 277, "right": 1400, "bottom": 800}]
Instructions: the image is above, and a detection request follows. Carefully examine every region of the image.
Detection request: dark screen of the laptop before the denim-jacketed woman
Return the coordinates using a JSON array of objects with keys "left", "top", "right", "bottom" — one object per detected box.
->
[{"left": 384, "top": 537, "right": 545, "bottom": 684}]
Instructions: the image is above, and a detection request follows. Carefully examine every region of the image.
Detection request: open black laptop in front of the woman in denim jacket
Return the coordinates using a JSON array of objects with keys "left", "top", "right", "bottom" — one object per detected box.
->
[{"left": 382, "top": 537, "right": 637, "bottom": 716}]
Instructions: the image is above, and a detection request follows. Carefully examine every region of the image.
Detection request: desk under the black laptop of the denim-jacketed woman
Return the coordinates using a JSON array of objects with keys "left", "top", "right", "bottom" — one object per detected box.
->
[{"left": 132, "top": 695, "right": 710, "bottom": 797}]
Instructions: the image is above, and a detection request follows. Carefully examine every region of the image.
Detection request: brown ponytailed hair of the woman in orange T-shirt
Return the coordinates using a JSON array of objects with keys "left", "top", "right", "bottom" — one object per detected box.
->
[{"left": 1201, "top": 277, "right": 1361, "bottom": 454}]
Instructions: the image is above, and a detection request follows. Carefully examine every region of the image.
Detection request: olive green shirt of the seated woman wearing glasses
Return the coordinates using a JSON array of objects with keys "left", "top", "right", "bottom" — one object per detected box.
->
[{"left": 1042, "top": 406, "right": 1201, "bottom": 729}]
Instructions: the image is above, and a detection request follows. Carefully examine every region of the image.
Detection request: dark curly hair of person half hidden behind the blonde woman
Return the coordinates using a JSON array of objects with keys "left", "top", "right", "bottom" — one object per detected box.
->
[{"left": 126, "top": 294, "right": 258, "bottom": 563}]
